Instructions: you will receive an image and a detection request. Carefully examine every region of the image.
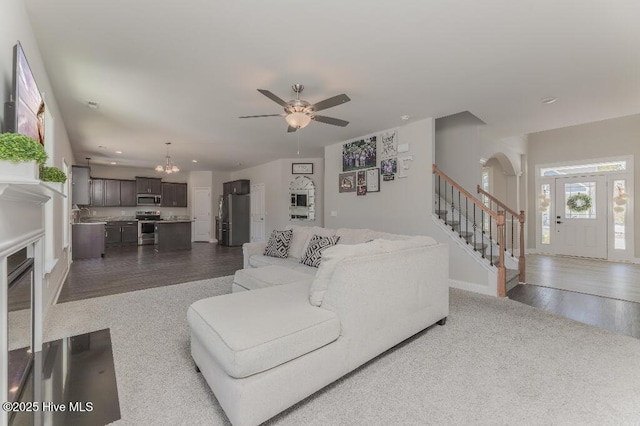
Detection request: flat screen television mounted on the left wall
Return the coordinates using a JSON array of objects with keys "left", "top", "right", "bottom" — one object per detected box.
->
[{"left": 4, "top": 42, "right": 44, "bottom": 145}]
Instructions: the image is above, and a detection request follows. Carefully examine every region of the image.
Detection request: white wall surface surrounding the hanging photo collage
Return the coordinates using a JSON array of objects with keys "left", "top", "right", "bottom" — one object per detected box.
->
[{"left": 324, "top": 118, "right": 435, "bottom": 235}]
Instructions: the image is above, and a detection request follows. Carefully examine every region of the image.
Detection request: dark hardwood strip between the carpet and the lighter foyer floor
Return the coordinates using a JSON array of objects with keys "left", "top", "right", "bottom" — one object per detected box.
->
[{"left": 507, "top": 284, "right": 640, "bottom": 339}]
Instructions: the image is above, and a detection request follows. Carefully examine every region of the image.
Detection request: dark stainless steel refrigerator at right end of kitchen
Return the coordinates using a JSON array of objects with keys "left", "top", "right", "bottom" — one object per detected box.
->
[{"left": 216, "top": 194, "right": 251, "bottom": 246}]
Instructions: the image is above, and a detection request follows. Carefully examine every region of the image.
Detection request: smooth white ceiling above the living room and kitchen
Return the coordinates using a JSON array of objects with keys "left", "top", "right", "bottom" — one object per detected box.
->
[{"left": 25, "top": 0, "right": 640, "bottom": 171}]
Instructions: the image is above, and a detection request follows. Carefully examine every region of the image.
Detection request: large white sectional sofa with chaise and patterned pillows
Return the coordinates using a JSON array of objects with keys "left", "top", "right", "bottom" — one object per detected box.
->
[{"left": 187, "top": 227, "right": 449, "bottom": 426}]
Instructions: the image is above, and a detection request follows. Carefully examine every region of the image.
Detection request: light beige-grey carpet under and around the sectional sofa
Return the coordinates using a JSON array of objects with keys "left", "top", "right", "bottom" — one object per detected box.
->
[{"left": 47, "top": 277, "right": 640, "bottom": 426}]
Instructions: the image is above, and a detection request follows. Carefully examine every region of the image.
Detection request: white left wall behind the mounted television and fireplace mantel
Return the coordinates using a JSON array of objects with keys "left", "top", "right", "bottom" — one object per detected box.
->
[{"left": 0, "top": 0, "right": 74, "bottom": 317}]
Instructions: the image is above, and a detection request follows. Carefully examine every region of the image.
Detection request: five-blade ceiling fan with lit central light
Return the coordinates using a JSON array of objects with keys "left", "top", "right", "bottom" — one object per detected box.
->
[{"left": 239, "top": 84, "right": 351, "bottom": 132}]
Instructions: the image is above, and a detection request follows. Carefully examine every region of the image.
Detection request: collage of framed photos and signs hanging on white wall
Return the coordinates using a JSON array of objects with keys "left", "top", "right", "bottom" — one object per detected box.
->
[{"left": 338, "top": 129, "right": 398, "bottom": 196}]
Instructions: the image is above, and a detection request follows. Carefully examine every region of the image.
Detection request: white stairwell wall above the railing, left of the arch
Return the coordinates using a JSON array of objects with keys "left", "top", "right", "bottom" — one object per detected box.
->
[{"left": 435, "top": 111, "right": 484, "bottom": 194}]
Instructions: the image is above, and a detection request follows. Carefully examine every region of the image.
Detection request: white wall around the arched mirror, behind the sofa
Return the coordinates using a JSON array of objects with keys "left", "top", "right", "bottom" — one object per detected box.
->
[{"left": 230, "top": 158, "right": 324, "bottom": 237}]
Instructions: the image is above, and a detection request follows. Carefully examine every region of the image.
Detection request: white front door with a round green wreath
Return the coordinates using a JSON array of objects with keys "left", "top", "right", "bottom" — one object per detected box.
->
[{"left": 552, "top": 176, "right": 608, "bottom": 259}]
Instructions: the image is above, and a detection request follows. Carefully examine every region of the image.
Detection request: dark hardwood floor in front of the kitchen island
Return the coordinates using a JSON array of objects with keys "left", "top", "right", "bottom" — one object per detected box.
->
[{"left": 58, "top": 243, "right": 242, "bottom": 303}]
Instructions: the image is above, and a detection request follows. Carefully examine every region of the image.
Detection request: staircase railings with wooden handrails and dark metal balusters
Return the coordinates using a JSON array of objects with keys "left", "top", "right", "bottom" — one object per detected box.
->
[{"left": 433, "top": 165, "right": 525, "bottom": 297}]
